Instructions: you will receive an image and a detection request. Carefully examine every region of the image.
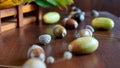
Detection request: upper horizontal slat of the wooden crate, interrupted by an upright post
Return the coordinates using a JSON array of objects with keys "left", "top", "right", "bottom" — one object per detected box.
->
[{"left": 0, "top": 4, "right": 35, "bottom": 18}]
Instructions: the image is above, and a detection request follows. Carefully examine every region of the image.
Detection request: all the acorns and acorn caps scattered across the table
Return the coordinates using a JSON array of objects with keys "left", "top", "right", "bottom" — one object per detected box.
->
[{"left": 22, "top": 6, "right": 114, "bottom": 68}]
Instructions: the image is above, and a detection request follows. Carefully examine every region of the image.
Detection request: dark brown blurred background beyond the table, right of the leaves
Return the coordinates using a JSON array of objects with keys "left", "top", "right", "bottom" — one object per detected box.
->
[{"left": 74, "top": 0, "right": 120, "bottom": 16}]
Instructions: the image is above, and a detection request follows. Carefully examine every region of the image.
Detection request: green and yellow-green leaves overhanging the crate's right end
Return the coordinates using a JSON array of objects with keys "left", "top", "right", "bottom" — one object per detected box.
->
[{"left": 35, "top": 0, "right": 74, "bottom": 8}]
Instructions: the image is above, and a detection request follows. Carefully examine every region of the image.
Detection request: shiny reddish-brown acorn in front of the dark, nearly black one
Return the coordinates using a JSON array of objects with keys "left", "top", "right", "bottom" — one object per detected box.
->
[{"left": 63, "top": 18, "right": 78, "bottom": 29}]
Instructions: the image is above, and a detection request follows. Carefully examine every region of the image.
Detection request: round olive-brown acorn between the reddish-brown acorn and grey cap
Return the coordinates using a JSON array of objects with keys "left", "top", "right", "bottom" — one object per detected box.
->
[{"left": 53, "top": 25, "right": 67, "bottom": 38}]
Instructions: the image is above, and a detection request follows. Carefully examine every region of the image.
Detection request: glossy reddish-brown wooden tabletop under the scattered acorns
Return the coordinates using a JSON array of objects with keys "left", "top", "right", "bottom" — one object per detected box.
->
[{"left": 0, "top": 12, "right": 120, "bottom": 68}]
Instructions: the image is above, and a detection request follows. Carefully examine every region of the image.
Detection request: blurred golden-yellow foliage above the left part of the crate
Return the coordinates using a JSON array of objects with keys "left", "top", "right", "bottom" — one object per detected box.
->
[{"left": 0, "top": 0, "right": 32, "bottom": 9}]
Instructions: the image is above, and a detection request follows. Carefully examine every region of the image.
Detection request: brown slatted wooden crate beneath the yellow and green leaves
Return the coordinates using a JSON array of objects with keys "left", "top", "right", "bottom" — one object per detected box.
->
[{"left": 0, "top": 4, "right": 42, "bottom": 33}]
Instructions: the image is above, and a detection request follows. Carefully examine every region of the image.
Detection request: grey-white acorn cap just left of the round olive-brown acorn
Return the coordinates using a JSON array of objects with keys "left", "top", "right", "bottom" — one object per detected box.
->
[{"left": 39, "top": 34, "right": 51, "bottom": 45}]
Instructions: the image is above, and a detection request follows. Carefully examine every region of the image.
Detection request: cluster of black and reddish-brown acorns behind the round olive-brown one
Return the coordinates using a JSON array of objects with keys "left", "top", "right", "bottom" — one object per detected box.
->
[{"left": 62, "top": 6, "right": 85, "bottom": 29}]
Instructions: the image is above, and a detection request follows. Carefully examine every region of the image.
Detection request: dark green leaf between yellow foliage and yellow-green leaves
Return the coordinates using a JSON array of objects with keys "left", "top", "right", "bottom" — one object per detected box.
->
[{"left": 35, "top": 0, "right": 54, "bottom": 8}]
